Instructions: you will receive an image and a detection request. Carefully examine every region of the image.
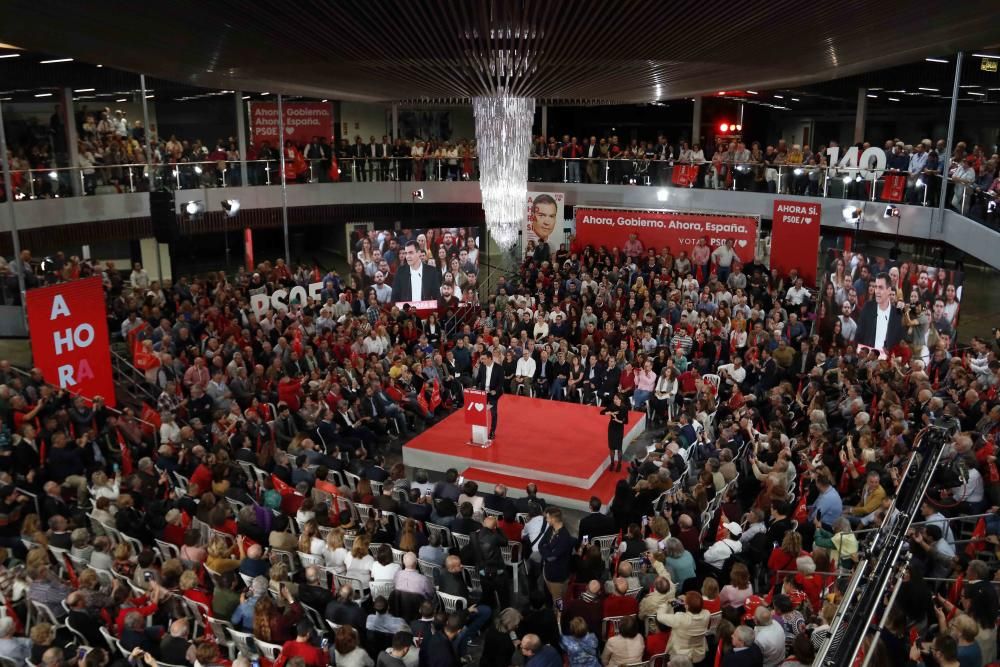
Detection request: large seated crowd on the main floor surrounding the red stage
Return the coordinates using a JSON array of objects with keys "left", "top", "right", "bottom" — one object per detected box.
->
[{"left": 0, "top": 220, "right": 1000, "bottom": 667}]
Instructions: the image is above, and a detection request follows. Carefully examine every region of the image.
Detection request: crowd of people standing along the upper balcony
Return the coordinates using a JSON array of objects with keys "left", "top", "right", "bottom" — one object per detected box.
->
[{"left": 3, "top": 106, "right": 1000, "bottom": 224}]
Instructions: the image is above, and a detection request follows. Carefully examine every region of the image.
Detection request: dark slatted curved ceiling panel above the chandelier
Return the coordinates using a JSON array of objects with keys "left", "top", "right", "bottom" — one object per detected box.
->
[{"left": 0, "top": 0, "right": 1000, "bottom": 103}]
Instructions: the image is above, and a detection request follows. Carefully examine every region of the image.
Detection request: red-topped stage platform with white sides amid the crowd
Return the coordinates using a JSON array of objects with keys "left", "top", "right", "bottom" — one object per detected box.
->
[{"left": 403, "top": 394, "right": 646, "bottom": 509}]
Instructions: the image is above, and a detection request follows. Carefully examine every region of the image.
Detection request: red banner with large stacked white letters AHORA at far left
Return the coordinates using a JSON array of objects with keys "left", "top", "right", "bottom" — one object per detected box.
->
[{"left": 25, "top": 278, "right": 115, "bottom": 406}]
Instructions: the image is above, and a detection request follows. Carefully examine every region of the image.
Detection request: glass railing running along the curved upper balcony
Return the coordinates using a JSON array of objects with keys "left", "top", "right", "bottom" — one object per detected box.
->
[{"left": 0, "top": 157, "right": 1000, "bottom": 228}]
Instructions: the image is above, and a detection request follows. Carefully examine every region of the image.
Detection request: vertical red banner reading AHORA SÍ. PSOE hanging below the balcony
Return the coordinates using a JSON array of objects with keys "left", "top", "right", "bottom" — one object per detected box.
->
[{"left": 771, "top": 199, "right": 823, "bottom": 287}]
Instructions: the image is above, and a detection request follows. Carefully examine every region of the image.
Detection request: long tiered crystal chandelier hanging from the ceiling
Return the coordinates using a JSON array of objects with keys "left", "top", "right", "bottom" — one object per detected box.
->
[{"left": 472, "top": 96, "right": 535, "bottom": 250}]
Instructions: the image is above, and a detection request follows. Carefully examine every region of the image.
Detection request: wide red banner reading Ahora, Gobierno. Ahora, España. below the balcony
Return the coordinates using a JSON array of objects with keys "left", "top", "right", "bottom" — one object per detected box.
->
[{"left": 573, "top": 206, "right": 757, "bottom": 262}]
